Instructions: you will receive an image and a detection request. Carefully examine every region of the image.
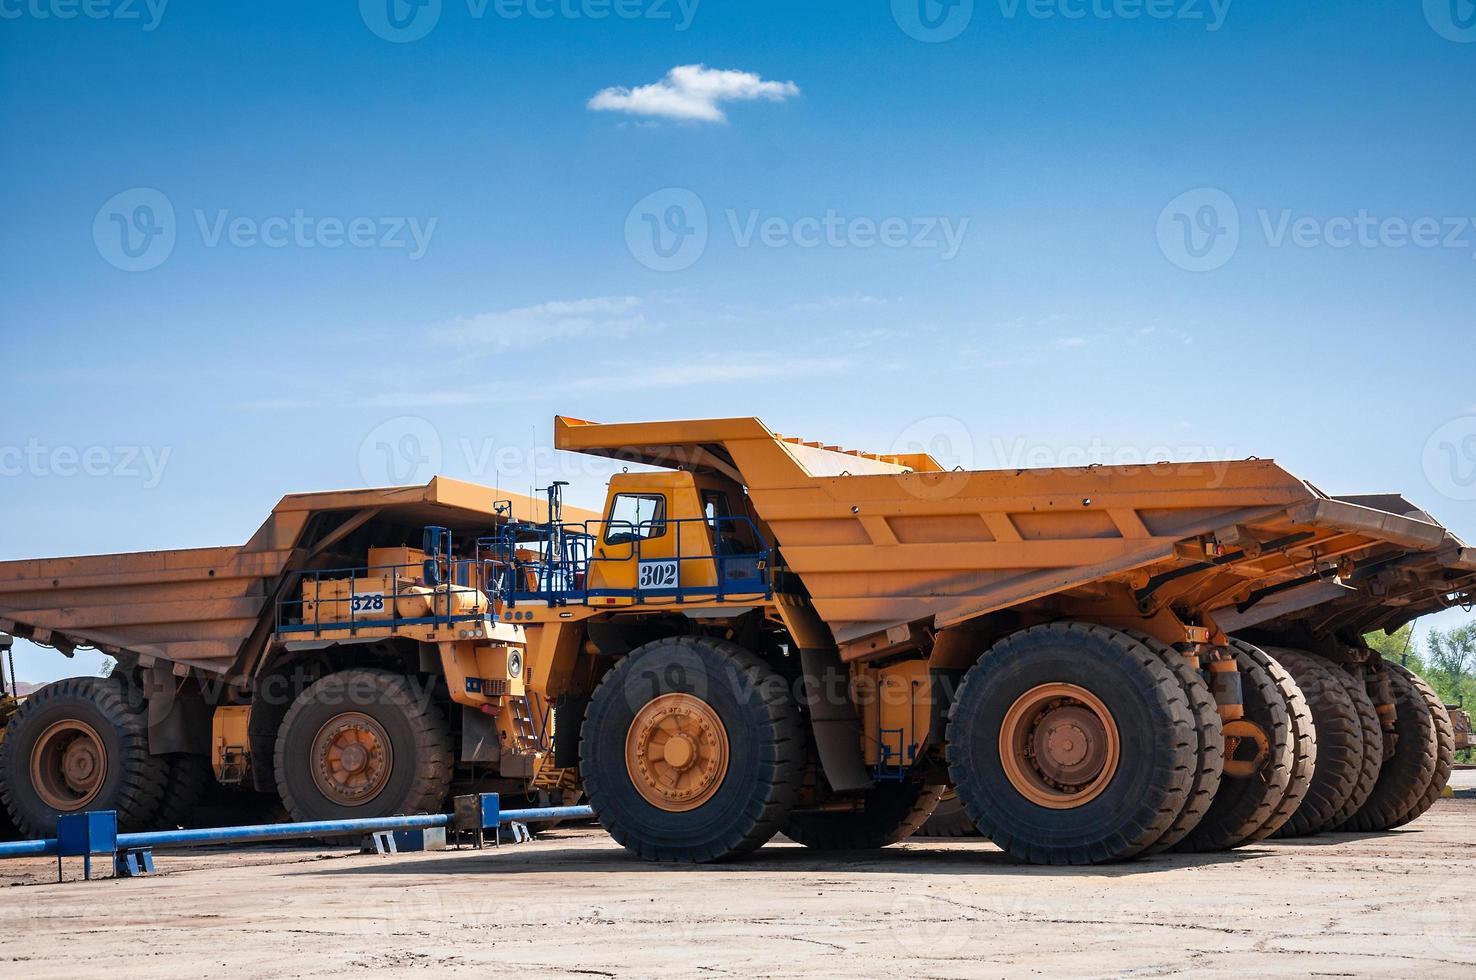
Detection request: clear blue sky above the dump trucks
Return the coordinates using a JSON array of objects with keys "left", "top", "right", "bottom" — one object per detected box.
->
[{"left": 0, "top": 0, "right": 1476, "bottom": 680}]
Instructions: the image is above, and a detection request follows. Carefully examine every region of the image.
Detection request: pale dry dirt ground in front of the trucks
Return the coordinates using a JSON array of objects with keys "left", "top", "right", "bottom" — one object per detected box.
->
[{"left": 0, "top": 772, "right": 1476, "bottom": 980}]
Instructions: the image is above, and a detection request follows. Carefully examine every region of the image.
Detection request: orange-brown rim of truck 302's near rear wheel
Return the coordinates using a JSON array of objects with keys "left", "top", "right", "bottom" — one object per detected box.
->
[{"left": 999, "top": 683, "right": 1122, "bottom": 810}]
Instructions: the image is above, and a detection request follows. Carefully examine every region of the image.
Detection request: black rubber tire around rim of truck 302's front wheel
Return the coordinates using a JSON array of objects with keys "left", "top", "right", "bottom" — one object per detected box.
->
[{"left": 580, "top": 636, "right": 806, "bottom": 862}]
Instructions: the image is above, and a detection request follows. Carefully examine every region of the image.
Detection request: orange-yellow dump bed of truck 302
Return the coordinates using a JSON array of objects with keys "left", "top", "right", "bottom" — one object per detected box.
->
[{"left": 555, "top": 418, "right": 1444, "bottom": 645}]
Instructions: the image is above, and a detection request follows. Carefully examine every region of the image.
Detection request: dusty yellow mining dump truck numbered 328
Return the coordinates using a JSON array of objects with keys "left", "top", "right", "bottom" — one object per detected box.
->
[{"left": 0, "top": 478, "right": 593, "bottom": 837}]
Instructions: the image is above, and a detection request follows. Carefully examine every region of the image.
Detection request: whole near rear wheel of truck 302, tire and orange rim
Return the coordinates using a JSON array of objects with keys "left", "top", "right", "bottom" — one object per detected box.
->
[{"left": 948, "top": 623, "right": 1203, "bottom": 865}]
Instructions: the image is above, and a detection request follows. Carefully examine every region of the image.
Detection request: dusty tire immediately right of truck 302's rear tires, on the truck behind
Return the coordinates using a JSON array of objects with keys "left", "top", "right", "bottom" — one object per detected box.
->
[{"left": 1266, "top": 646, "right": 1364, "bottom": 837}]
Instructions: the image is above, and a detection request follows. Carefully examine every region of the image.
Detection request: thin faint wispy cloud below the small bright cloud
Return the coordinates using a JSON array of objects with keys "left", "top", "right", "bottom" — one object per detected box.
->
[{"left": 431, "top": 297, "right": 646, "bottom": 350}]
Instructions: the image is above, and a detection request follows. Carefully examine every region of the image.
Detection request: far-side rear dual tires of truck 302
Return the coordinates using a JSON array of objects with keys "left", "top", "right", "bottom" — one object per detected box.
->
[{"left": 1173, "top": 643, "right": 1296, "bottom": 852}]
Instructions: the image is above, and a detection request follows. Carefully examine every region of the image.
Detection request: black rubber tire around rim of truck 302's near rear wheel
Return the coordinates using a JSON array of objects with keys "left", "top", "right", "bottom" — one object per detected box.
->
[{"left": 948, "top": 623, "right": 1199, "bottom": 865}]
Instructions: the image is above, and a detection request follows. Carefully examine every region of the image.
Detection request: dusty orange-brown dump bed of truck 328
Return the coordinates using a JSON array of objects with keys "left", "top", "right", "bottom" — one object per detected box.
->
[{"left": 0, "top": 477, "right": 593, "bottom": 676}]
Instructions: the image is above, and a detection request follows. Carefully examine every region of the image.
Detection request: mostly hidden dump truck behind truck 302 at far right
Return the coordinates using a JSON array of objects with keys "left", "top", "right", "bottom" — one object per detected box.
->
[{"left": 920, "top": 494, "right": 1476, "bottom": 837}]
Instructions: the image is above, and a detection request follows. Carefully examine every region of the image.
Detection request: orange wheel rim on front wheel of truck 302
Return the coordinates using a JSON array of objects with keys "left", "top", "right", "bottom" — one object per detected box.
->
[{"left": 626, "top": 694, "right": 728, "bottom": 813}]
